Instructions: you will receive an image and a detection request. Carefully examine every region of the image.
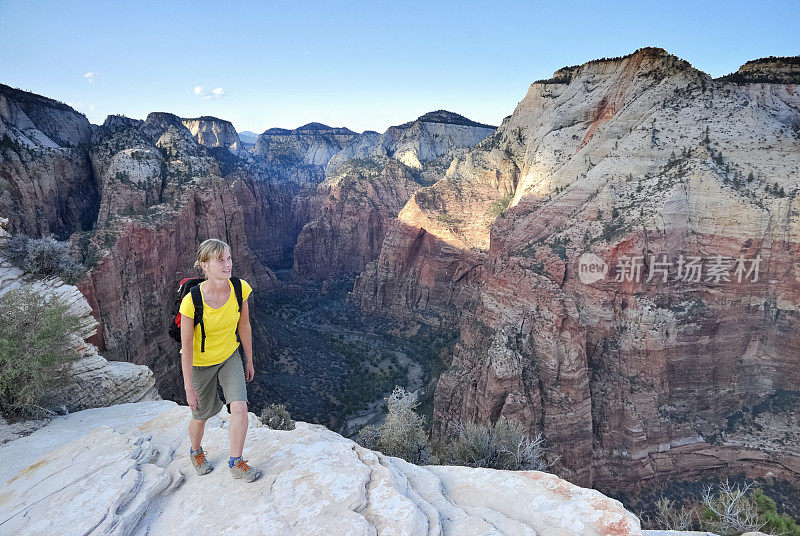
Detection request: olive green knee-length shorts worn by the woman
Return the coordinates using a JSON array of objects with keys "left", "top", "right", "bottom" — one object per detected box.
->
[{"left": 192, "top": 348, "right": 247, "bottom": 421}]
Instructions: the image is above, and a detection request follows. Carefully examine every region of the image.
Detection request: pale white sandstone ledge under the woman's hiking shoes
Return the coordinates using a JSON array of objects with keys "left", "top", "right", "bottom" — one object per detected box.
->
[{"left": 0, "top": 401, "right": 642, "bottom": 536}]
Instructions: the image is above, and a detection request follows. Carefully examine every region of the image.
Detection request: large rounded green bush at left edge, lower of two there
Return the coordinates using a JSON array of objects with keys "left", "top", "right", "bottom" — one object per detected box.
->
[{"left": 0, "top": 289, "right": 81, "bottom": 417}]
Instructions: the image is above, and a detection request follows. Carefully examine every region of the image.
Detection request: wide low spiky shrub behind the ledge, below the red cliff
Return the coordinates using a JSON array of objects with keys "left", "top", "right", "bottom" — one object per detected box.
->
[{"left": 440, "top": 417, "right": 549, "bottom": 471}]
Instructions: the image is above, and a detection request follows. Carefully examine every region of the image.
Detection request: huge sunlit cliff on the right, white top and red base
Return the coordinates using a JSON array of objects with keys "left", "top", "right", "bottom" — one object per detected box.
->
[{"left": 353, "top": 49, "right": 800, "bottom": 486}]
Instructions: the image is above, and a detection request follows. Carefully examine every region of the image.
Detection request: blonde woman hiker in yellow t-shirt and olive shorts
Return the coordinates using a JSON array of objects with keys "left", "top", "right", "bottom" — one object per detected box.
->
[{"left": 180, "top": 238, "right": 261, "bottom": 482}]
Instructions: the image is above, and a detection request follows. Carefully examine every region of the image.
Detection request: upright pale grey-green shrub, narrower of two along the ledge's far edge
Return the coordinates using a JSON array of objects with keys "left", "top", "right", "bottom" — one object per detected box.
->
[{"left": 359, "top": 386, "right": 431, "bottom": 464}]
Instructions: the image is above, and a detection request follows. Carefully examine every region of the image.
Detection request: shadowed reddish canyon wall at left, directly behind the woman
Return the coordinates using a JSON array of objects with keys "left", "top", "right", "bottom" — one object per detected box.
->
[{"left": 0, "top": 100, "right": 277, "bottom": 399}]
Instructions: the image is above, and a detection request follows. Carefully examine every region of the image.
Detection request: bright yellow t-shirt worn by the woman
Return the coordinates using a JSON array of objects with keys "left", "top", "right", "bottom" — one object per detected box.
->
[{"left": 180, "top": 279, "right": 253, "bottom": 367}]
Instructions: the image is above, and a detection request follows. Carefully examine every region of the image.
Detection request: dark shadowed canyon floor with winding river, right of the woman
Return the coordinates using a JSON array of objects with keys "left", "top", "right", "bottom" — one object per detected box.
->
[{"left": 249, "top": 270, "right": 453, "bottom": 437}]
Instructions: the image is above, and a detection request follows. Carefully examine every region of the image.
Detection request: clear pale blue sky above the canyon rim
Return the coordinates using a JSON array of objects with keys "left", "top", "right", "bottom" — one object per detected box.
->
[{"left": 0, "top": 0, "right": 800, "bottom": 132}]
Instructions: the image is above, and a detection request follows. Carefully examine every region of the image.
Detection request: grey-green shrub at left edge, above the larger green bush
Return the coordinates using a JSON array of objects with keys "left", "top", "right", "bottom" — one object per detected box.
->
[{"left": 4, "top": 235, "right": 85, "bottom": 285}]
